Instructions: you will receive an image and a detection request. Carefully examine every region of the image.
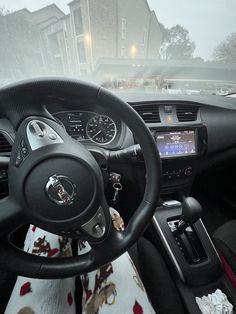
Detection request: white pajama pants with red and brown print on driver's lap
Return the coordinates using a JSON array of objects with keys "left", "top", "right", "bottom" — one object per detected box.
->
[{"left": 5, "top": 220, "right": 155, "bottom": 314}]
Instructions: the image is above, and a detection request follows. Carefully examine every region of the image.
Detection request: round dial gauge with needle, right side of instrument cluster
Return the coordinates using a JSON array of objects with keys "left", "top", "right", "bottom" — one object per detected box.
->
[{"left": 86, "top": 115, "right": 117, "bottom": 145}]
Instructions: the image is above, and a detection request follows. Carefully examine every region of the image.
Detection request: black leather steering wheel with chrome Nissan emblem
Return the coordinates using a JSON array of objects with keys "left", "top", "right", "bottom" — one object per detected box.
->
[{"left": 0, "top": 78, "right": 161, "bottom": 279}]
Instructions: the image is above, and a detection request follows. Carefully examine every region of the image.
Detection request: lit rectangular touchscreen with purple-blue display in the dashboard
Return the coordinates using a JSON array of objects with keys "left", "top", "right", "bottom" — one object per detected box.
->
[{"left": 156, "top": 131, "right": 196, "bottom": 158}]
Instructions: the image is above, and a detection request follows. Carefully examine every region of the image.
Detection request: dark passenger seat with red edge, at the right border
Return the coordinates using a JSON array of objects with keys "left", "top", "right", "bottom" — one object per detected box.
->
[{"left": 213, "top": 220, "right": 236, "bottom": 288}]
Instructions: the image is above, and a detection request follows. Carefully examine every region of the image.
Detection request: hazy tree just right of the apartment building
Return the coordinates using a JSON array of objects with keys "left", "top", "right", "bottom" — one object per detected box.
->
[{"left": 160, "top": 24, "right": 196, "bottom": 60}]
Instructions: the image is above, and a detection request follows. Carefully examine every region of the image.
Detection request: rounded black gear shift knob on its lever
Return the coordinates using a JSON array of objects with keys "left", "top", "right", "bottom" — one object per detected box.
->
[{"left": 177, "top": 197, "right": 202, "bottom": 232}]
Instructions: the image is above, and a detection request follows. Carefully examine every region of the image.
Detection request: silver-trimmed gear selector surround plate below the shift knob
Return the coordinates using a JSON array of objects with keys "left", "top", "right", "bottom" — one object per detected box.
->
[{"left": 153, "top": 198, "right": 221, "bottom": 285}]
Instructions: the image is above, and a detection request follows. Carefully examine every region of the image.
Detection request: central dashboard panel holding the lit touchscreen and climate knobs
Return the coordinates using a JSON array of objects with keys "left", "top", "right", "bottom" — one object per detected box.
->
[{"left": 150, "top": 124, "right": 207, "bottom": 193}]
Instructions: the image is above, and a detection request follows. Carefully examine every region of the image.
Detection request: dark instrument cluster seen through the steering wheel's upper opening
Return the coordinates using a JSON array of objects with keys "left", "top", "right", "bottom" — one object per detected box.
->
[{"left": 53, "top": 111, "right": 118, "bottom": 145}]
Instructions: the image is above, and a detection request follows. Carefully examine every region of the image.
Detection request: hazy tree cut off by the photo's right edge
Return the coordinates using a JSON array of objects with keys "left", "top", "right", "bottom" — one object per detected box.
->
[{"left": 213, "top": 33, "right": 236, "bottom": 63}]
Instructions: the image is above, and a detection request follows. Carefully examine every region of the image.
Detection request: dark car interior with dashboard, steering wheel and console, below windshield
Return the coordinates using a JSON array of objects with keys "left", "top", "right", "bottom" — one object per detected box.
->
[{"left": 0, "top": 79, "right": 236, "bottom": 313}]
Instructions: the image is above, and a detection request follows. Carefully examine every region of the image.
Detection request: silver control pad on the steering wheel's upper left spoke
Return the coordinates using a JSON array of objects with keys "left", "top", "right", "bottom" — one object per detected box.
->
[{"left": 26, "top": 120, "right": 64, "bottom": 150}]
